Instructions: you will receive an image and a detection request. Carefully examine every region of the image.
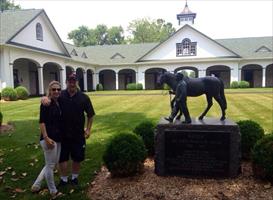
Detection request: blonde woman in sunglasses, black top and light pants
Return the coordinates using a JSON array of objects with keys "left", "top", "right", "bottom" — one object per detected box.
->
[{"left": 31, "top": 81, "right": 62, "bottom": 199}]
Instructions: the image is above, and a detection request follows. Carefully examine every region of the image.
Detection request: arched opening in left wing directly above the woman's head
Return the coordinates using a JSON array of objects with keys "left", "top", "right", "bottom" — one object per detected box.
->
[{"left": 43, "top": 62, "right": 61, "bottom": 91}]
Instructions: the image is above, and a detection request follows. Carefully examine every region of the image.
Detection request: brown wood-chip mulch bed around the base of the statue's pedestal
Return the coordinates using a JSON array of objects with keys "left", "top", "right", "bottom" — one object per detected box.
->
[{"left": 88, "top": 159, "right": 273, "bottom": 200}]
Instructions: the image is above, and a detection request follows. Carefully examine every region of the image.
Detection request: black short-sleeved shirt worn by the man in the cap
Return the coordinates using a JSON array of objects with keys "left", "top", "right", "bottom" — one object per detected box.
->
[{"left": 59, "top": 90, "right": 95, "bottom": 140}]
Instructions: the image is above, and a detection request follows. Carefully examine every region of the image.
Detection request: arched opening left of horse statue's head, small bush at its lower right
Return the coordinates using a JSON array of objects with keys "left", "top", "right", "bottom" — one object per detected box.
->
[{"left": 118, "top": 69, "right": 136, "bottom": 90}]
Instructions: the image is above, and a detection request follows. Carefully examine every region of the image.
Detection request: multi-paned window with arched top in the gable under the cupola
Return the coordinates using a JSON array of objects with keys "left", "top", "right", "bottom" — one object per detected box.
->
[{"left": 176, "top": 38, "right": 196, "bottom": 56}]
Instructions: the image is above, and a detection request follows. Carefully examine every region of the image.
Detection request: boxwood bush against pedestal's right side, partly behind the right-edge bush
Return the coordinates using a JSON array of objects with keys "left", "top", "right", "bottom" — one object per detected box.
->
[{"left": 237, "top": 120, "right": 264, "bottom": 159}]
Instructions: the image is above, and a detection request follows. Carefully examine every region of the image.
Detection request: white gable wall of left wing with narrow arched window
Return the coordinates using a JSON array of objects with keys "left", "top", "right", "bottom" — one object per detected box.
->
[{"left": 8, "top": 12, "right": 69, "bottom": 56}]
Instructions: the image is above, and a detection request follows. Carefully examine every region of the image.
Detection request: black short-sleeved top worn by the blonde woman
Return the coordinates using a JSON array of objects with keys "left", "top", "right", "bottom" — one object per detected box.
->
[{"left": 39, "top": 100, "right": 62, "bottom": 142}]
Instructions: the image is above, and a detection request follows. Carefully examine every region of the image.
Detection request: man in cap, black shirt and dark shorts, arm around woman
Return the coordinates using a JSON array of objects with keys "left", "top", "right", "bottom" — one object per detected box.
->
[{"left": 42, "top": 73, "right": 95, "bottom": 186}]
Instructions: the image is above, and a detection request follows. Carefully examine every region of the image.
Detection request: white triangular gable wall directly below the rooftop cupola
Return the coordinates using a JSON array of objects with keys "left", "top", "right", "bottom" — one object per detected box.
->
[{"left": 140, "top": 25, "right": 238, "bottom": 61}]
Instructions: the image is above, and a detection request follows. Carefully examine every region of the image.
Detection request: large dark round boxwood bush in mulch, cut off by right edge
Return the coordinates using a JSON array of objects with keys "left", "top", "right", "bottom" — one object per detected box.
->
[{"left": 251, "top": 132, "right": 273, "bottom": 182}]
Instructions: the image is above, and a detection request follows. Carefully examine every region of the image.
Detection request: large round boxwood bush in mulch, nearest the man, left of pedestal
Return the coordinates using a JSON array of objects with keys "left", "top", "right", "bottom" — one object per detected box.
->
[{"left": 103, "top": 133, "right": 147, "bottom": 177}]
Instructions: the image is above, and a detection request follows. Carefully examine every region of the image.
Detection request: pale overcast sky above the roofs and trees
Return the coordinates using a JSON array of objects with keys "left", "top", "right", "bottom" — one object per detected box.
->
[{"left": 14, "top": 0, "right": 273, "bottom": 43}]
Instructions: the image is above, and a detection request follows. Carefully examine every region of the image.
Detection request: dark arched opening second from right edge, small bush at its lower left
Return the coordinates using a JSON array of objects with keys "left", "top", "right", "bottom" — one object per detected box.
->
[{"left": 241, "top": 64, "right": 263, "bottom": 87}]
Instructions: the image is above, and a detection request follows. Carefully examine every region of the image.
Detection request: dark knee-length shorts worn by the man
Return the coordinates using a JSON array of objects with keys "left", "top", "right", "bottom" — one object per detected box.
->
[{"left": 59, "top": 138, "right": 85, "bottom": 163}]
